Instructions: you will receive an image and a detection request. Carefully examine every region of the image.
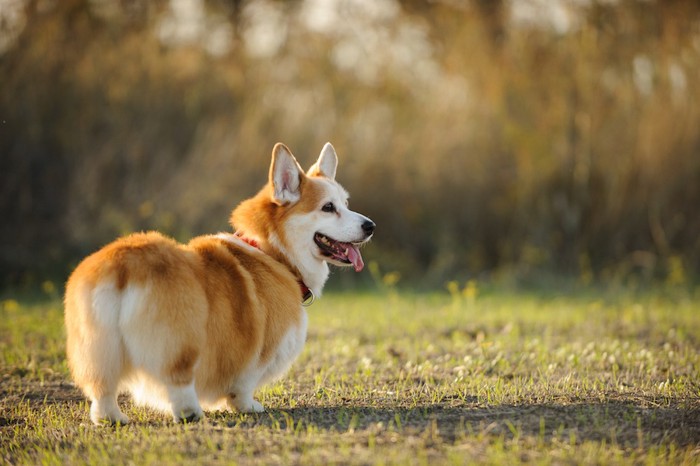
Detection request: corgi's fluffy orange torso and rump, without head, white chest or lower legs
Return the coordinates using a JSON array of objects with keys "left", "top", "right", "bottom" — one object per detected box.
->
[{"left": 65, "top": 232, "right": 302, "bottom": 404}]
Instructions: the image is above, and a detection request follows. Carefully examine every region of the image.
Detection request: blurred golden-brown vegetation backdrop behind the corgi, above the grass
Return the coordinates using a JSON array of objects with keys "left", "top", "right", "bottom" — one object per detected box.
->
[{"left": 0, "top": 0, "right": 700, "bottom": 287}]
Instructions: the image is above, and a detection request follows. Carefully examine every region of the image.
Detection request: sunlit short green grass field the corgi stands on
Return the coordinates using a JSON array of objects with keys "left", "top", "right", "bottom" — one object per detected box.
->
[{"left": 0, "top": 284, "right": 700, "bottom": 465}]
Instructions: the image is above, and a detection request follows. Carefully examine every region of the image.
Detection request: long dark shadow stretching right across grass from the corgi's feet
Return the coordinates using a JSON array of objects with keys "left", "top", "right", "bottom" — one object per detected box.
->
[{"left": 215, "top": 398, "right": 700, "bottom": 447}]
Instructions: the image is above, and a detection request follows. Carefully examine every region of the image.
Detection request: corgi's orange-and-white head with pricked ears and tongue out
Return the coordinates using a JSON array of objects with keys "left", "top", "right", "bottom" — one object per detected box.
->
[{"left": 231, "top": 143, "right": 375, "bottom": 286}]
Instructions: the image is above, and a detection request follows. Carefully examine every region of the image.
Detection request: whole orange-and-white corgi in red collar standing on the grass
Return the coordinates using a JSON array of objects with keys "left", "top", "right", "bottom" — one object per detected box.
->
[{"left": 65, "top": 143, "right": 375, "bottom": 424}]
